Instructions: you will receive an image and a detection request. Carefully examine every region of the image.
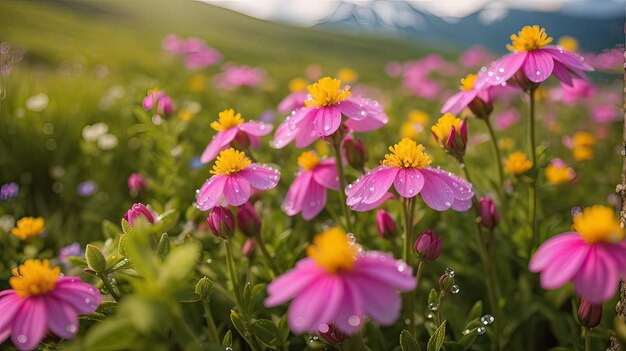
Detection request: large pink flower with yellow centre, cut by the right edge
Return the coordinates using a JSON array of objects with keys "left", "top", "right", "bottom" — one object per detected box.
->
[{"left": 528, "top": 206, "right": 626, "bottom": 304}]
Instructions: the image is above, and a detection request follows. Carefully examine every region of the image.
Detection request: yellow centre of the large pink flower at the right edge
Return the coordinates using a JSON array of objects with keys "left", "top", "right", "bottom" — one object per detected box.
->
[{"left": 574, "top": 206, "right": 624, "bottom": 244}]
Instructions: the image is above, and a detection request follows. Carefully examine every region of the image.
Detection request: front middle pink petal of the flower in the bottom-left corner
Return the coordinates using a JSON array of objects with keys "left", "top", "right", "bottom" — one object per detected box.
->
[{"left": 11, "top": 296, "right": 48, "bottom": 350}]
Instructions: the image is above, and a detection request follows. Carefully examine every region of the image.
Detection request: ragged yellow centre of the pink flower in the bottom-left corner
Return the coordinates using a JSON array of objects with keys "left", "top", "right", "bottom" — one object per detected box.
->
[{"left": 9, "top": 259, "right": 61, "bottom": 297}]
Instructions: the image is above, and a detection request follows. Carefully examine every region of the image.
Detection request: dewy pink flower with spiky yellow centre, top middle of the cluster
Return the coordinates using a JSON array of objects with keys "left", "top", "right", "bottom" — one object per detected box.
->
[{"left": 272, "top": 77, "right": 388, "bottom": 149}]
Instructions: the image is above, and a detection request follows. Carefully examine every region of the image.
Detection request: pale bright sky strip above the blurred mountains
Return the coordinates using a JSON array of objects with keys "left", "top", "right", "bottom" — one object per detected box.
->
[{"left": 200, "top": 0, "right": 626, "bottom": 27}]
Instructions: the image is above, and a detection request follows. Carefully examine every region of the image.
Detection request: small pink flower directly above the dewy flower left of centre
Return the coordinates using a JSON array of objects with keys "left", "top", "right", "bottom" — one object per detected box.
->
[{"left": 200, "top": 109, "right": 274, "bottom": 163}]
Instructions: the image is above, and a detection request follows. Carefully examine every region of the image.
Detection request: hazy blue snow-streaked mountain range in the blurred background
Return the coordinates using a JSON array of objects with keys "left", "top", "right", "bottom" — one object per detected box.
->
[{"left": 317, "top": 0, "right": 624, "bottom": 52}]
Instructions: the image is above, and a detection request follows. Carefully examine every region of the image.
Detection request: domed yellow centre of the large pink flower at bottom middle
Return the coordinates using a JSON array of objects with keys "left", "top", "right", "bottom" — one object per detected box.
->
[{"left": 306, "top": 227, "right": 358, "bottom": 273}]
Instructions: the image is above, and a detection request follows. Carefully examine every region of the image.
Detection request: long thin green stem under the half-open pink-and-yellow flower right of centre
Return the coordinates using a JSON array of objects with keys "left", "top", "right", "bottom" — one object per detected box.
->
[{"left": 460, "top": 163, "right": 502, "bottom": 350}]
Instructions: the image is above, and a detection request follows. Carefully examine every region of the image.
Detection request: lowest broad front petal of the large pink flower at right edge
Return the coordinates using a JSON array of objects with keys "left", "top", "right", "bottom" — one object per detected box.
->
[{"left": 574, "top": 245, "right": 619, "bottom": 304}]
